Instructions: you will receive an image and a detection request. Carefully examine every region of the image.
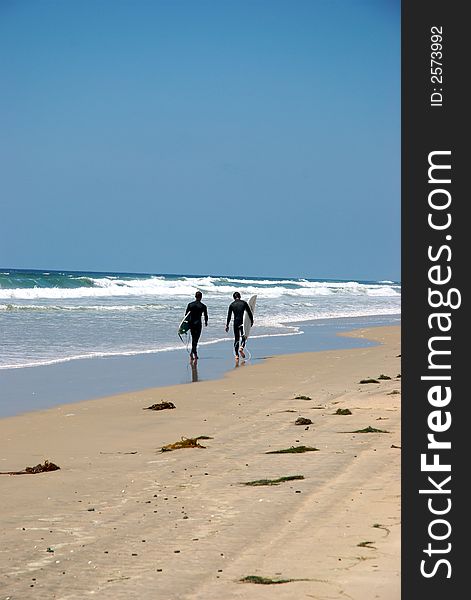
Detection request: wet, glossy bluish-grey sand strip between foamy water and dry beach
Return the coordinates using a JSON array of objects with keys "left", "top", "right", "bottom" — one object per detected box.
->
[{"left": 0, "top": 315, "right": 400, "bottom": 419}]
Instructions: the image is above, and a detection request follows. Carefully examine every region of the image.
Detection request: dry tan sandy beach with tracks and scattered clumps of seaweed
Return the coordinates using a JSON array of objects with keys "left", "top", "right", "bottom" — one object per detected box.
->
[{"left": 0, "top": 327, "right": 401, "bottom": 600}]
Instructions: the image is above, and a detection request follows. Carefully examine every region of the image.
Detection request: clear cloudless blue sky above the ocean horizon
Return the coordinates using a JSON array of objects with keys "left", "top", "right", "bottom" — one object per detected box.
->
[{"left": 0, "top": 0, "right": 400, "bottom": 279}]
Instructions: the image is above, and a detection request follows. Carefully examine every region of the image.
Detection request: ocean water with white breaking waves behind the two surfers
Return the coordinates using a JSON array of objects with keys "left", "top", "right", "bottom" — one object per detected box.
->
[{"left": 0, "top": 268, "right": 401, "bottom": 369}]
